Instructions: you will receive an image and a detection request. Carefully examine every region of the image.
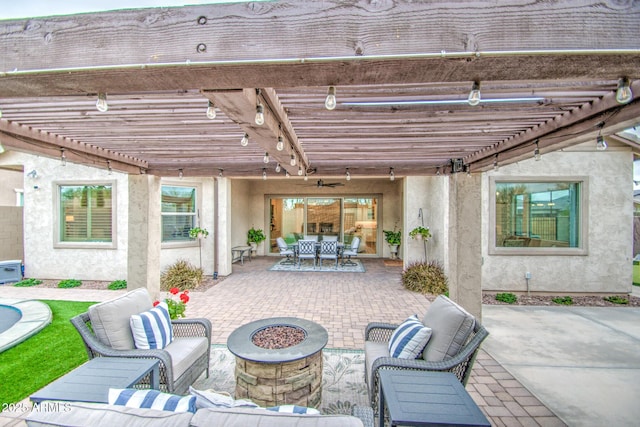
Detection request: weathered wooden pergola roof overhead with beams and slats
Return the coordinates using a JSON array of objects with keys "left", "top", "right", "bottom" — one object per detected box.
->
[{"left": 0, "top": 1, "right": 640, "bottom": 177}]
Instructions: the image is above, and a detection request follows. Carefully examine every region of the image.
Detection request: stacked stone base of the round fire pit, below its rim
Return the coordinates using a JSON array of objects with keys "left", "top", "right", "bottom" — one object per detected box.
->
[{"left": 235, "top": 350, "right": 322, "bottom": 408}]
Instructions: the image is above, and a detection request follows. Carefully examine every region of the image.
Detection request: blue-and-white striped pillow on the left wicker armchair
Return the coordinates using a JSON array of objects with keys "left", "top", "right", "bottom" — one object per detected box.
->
[{"left": 130, "top": 302, "right": 173, "bottom": 350}]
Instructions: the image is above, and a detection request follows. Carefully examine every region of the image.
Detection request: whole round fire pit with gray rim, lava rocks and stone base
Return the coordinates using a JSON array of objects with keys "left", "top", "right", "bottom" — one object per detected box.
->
[{"left": 227, "top": 317, "right": 329, "bottom": 407}]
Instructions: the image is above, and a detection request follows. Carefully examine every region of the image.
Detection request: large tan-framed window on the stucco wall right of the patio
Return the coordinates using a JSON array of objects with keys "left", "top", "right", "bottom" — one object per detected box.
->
[{"left": 489, "top": 177, "right": 588, "bottom": 255}]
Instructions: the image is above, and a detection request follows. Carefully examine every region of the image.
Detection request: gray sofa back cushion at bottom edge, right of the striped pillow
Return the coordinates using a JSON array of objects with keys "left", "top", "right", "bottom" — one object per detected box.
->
[{"left": 191, "top": 408, "right": 363, "bottom": 427}]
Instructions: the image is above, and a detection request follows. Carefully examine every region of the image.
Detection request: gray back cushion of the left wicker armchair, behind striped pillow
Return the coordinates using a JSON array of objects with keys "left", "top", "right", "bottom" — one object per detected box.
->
[{"left": 89, "top": 288, "right": 153, "bottom": 350}]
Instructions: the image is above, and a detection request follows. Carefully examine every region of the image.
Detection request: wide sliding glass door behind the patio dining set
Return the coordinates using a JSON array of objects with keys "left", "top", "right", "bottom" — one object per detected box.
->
[{"left": 269, "top": 196, "right": 378, "bottom": 255}]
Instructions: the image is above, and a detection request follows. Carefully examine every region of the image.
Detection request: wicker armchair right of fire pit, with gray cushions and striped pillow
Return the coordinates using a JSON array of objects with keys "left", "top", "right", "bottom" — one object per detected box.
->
[{"left": 365, "top": 295, "right": 489, "bottom": 411}]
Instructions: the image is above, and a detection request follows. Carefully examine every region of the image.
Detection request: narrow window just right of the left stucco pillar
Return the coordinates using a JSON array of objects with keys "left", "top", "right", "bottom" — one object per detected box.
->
[{"left": 161, "top": 183, "right": 201, "bottom": 245}]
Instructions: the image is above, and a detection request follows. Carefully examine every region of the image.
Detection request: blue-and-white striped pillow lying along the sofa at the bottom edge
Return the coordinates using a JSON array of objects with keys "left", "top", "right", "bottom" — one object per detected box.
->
[{"left": 108, "top": 388, "right": 196, "bottom": 414}]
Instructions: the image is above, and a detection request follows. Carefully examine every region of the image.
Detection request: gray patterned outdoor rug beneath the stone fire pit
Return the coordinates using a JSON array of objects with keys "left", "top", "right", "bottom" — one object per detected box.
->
[{"left": 193, "top": 344, "right": 369, "bottom": 415}]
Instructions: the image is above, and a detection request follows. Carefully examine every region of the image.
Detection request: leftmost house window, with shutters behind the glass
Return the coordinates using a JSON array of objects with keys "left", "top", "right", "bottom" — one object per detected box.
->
[{"left": 54, "top": 181, "right": 117, "bottom": 249}]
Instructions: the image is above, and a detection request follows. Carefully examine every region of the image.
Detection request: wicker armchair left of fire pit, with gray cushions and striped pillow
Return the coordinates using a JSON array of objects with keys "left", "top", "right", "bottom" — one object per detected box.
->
[{"left": 71, "top": 288, "right": 211, "bottom": 394}]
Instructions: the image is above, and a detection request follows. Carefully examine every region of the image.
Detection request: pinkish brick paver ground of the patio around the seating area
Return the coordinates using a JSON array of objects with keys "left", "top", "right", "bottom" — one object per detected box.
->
[{"left": 0, "top": 257, "right": 564, "bottom": 426}]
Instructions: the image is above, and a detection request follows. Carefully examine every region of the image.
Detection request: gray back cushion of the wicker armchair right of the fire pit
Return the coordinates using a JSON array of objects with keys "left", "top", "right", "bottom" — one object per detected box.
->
[{"left": 422, "top": 295, "right": 476, "bottom": 362}]
